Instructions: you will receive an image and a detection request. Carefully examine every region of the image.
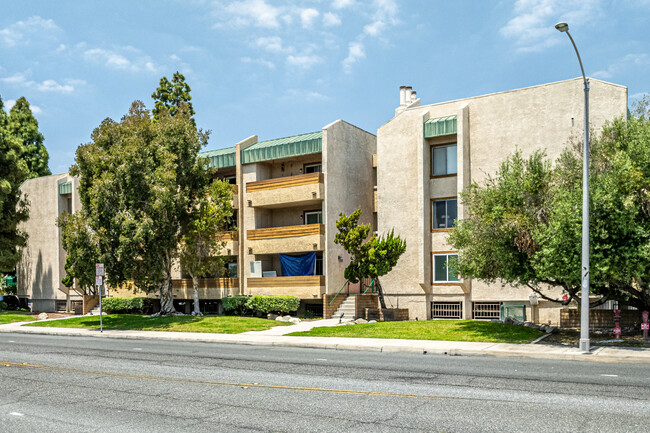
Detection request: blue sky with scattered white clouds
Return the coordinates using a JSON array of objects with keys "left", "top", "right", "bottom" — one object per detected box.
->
[{"left": 0, "top": 0, "right": 650, "bottom": 173}]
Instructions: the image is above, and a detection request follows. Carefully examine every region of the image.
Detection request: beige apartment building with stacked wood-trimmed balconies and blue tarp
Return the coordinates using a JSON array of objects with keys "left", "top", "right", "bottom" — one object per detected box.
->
[{"left": 18, "top": 120, "right": 376, "bottom": 314}]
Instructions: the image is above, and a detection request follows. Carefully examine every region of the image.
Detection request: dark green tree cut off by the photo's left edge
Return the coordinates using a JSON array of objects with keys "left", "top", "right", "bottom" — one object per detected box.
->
[{"left": 0, "top": 98, "right": 29, "bottom": 272}]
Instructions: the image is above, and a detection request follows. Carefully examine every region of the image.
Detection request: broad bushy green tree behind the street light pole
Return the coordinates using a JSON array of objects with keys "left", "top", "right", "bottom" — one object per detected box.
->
[{"left": 449, "top": 100, "right": 650, "bottom": 309}]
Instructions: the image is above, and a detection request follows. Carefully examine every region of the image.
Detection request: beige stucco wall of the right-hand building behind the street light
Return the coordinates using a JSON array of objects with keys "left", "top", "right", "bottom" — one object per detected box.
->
[{"left": 377, "top": 78, "right": 627, "bottom": 318}]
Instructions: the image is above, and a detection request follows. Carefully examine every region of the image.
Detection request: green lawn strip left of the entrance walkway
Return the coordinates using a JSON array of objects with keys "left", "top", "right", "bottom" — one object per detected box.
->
[{"left": 26, "top": 314, "right": 288, "bottom": 334}]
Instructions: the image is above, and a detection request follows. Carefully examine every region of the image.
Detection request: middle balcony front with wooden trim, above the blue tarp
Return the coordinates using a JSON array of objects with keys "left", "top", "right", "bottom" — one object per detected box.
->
[{"left": 246, "top": 224, "right": 325, "bottom": 254}]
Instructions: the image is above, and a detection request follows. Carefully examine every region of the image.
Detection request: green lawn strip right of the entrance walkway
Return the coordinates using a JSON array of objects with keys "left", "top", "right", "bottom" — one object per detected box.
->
[{"left": 288, "top": 320, "right": 543, "bottom": 343}]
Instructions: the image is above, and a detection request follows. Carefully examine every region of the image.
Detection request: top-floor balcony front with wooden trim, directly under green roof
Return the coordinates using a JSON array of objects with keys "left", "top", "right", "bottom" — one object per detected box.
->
[{"left": 246, "top": 173, "right": 325, "bottom": 208}]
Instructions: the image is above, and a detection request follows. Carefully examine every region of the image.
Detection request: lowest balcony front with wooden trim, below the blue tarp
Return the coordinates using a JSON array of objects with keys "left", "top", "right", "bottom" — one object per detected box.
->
[{"left": 246, "top": 275, "right": 325, "bottom": 299}]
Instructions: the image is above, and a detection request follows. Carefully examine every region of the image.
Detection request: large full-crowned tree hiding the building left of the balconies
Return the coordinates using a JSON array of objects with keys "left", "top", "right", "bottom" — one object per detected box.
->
[{"left": 63, "top": 101, "right": 211, "bottom": 315}]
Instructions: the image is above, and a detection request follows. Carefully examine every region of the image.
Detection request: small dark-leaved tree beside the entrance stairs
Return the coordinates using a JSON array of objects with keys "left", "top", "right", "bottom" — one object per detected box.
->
[{"left": 334, "top": 207, "right": 406, "bottom": 308}]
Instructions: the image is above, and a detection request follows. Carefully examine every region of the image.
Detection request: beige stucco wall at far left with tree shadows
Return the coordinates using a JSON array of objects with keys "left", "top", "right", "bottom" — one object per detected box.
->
[{"left": 16, "top": 173, "right": 80, "bottom": 311}]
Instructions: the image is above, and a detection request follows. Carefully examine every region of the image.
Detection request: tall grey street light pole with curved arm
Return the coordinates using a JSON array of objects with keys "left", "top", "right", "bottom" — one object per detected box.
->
[{"left": 555, "top": 23, "right": 589, "bottom": 353}]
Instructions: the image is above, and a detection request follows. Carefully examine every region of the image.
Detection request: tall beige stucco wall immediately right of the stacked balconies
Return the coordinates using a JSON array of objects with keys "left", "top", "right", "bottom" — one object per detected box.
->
[{"left": 323, "top": 120, "right": 377, "bottom": 293}]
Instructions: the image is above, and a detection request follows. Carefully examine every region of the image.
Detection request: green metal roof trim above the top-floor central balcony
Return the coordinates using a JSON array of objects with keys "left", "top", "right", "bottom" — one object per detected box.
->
[{"left": 242, "top": 131, "right": 323, "bottom": 164}]
